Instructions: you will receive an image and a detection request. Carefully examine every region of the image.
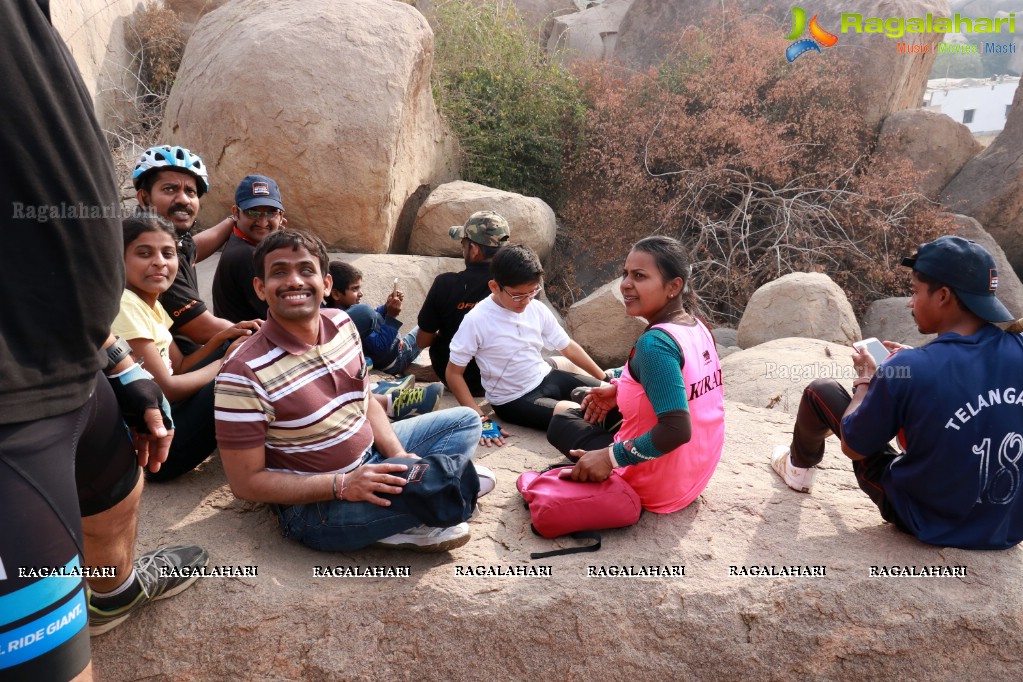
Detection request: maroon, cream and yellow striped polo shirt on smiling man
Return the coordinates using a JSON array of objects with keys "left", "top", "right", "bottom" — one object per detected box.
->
[{"left": 215, "top": 309, "right": 373, "bottom": 473}]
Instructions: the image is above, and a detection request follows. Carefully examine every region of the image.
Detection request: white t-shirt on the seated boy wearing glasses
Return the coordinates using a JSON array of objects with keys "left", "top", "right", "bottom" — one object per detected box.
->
[{"left": 451, "top": 297, "right": 572, "bottom": 405}]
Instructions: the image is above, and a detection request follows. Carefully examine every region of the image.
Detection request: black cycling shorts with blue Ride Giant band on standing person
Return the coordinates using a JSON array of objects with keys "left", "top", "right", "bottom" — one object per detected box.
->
[{"left": 0, "top": 375, "right": 140, "bottom": 682}]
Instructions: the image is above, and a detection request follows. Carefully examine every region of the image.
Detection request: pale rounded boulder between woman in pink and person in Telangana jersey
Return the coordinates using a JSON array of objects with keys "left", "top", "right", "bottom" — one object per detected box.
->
[{"left": 738, "top": 272, "right": 860, "bottom": 349}]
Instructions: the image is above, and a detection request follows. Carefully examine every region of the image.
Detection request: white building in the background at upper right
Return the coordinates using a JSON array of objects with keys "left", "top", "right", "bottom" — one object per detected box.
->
[{"left": 924, "top": 76, "right": 1020, "bottom": 135}]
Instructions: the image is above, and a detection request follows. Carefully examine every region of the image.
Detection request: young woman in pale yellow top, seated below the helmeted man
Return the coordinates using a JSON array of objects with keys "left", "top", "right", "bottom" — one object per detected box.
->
[{"left": 113, "top": 214, "right": 260, "bottom": 481}]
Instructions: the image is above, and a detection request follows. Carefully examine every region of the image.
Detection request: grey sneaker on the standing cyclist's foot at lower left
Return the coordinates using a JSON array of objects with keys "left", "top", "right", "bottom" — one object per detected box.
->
[{"left": 89, "top": 545, "right": 210, "bottom": 637}]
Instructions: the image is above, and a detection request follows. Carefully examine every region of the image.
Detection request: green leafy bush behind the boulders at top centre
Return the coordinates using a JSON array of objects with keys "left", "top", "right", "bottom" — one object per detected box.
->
[{"left": 428, "top": 0, "right": 582, "bottom": 207}]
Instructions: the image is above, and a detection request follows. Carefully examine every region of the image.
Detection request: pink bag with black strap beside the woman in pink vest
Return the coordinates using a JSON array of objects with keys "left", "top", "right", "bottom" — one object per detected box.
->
[{"left": 516, "top": 464, "right": 642, "bottom": 559}]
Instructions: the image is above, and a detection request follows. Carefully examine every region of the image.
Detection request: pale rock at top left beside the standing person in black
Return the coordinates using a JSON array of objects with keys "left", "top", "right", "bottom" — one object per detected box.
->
[{"left": 49, "top": 0, "right": 137, "bottom": 128}]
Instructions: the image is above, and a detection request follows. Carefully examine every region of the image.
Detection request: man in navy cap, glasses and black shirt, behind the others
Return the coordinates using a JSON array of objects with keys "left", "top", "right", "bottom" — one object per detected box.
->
[{"left": 213, "top": 175, "right": 284, "bottom": 322}]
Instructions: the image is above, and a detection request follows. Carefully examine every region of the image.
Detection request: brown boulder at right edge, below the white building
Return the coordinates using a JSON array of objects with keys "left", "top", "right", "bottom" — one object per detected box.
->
[{"left": 941, "top": 83, "right": 1023, "bottom": 275}]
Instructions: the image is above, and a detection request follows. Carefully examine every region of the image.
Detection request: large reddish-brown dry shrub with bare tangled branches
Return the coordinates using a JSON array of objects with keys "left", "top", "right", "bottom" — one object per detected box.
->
[{"left": 562, "top": 15, "right": 948, "bottom": 323}]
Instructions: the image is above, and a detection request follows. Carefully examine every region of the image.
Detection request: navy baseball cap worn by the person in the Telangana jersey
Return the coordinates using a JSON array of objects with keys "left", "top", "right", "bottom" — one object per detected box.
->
[{"left": 902, "top": 236, "right": 1016, "bottom": 322}]
